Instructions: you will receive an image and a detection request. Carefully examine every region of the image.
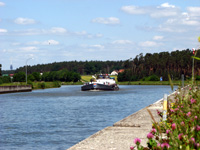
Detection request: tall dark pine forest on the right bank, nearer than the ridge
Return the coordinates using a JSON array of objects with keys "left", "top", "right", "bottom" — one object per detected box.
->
[{"left": 118, "top": 49, "right": 200, "bottom": 81}]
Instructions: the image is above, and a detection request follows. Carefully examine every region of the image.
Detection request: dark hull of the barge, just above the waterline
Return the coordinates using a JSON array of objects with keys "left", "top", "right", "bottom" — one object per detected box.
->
[{"left": 81, "top": 83, "right": 119, "bottom": 91}]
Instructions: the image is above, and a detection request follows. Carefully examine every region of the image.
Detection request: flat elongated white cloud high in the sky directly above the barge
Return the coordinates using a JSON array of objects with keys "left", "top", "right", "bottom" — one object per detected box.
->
[{"left": 92, "top": 17, "right": 120, "bottom": 25}]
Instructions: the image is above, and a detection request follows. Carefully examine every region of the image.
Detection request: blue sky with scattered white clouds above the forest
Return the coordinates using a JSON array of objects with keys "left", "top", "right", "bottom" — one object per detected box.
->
[{"left": 0, "top": 0, "right": 200, "bottom": 70}]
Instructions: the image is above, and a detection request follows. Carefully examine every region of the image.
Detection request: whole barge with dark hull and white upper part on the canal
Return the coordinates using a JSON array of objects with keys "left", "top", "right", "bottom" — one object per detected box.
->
[{"left": 81, "top": 74, "right": 119, "bottom": 91}]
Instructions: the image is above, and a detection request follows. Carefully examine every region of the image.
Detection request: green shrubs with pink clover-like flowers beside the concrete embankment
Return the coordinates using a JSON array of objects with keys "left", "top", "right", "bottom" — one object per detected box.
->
[{"left": 130, "top": 87, "right": 200, "bottom": 150}]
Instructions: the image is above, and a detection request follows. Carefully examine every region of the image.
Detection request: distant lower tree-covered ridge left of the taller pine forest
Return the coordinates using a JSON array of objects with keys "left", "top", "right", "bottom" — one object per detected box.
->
[{"left": 15, "top": 60, "right": 124, "bottom": 75}]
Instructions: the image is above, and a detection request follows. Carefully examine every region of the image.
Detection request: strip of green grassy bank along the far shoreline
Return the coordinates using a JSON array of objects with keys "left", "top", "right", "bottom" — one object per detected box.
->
[{"left": 0, "top": 75, "right": 200, "bottom": 90}]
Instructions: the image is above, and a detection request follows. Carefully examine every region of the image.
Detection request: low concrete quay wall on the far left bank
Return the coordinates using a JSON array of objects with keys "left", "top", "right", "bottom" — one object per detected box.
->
[{"left": 0, "top": 85, "right": 32, "bottom": 94}]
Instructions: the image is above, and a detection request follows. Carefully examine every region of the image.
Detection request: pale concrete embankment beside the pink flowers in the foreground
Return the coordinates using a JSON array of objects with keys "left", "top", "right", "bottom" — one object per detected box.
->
[{"left": 68, "top": 88, "right": 186, "bottom": 150}]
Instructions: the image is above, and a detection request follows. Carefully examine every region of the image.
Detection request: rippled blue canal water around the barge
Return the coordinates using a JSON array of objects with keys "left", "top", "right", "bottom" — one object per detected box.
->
[{"left": 0, "top": 85, "right": 171, "bottom": 150}]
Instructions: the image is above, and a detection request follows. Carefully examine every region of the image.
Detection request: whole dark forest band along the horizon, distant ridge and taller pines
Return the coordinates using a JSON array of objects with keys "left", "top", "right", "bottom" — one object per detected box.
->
[{"left": 3, "top": 49, "right": 200, "bottom": 81}]
